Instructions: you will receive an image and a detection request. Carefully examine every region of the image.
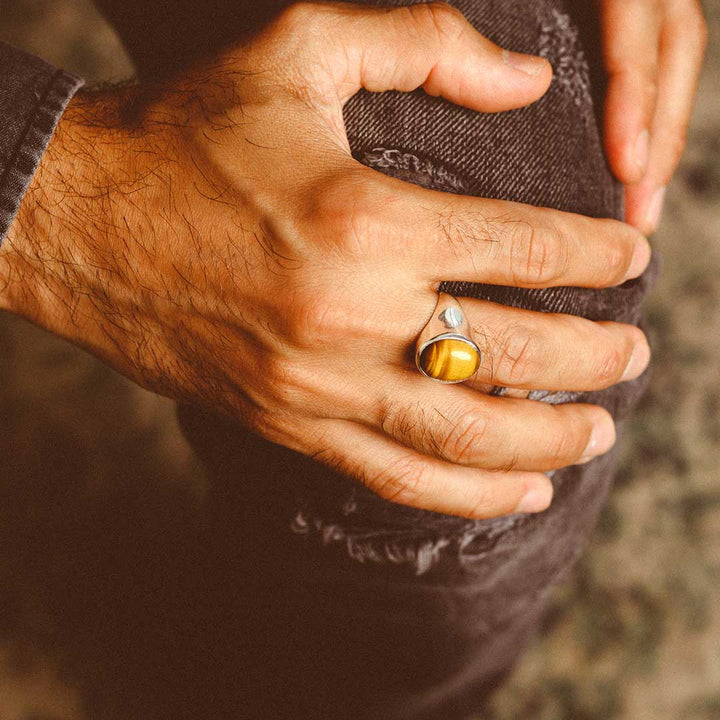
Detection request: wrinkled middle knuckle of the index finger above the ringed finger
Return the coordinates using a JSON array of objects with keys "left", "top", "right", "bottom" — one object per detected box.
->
[{"left": 510, "top": 222, "right": 568, "bottom": 286}]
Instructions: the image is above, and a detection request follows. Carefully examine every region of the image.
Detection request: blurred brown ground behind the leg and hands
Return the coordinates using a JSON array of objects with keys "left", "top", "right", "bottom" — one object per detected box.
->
[{"left": 0, "top": 0, "right": 720, "bottom": 720}]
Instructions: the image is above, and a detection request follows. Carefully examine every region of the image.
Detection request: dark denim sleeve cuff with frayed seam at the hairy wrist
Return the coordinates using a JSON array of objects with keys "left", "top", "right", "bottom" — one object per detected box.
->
[{"left": 0, "top": 43, "right": 83, "bottom": 242}]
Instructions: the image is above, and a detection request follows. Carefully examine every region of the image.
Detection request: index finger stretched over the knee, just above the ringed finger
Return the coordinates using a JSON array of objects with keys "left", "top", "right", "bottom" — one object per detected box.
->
[{"left": 386, "top": 186, "right": 651, "bottom": 288}]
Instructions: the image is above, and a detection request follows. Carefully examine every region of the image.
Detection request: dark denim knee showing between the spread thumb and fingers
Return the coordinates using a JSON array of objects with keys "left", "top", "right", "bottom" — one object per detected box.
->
[{"left": 345, "top": 0, "right": 658, "bottom": 404}]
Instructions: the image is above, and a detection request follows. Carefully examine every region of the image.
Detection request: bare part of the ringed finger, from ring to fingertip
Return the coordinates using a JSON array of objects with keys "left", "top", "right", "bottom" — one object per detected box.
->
[{"left": 459, "top": 298, "right": 650, "bottom": 391}]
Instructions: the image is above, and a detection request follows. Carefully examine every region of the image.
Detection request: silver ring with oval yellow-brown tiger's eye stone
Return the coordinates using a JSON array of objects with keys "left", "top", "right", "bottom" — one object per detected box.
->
[{"left": 415, "top": 293, "right": 482, "bottom": 383}]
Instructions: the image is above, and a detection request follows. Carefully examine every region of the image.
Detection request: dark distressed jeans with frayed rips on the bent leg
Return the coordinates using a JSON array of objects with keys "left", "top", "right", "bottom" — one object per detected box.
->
[{"left": 94, "top": 0, "right": 655, "bottom": 720}]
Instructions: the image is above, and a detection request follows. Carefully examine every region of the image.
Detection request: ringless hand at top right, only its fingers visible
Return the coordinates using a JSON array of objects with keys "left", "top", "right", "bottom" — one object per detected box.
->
[{"left": 600, "top": 0, "right": 707, "bottom": 234}]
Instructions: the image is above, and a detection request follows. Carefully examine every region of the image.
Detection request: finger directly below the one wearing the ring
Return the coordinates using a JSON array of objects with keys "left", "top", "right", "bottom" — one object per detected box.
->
[{"left": 369, "top": 372, "right": 615, "bottom": 471}]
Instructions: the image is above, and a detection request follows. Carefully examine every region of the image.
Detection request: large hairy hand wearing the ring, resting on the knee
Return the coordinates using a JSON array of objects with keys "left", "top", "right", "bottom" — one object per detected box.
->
[{"left": 0, "top": 4, "right": 650, "bottom": 517}]
